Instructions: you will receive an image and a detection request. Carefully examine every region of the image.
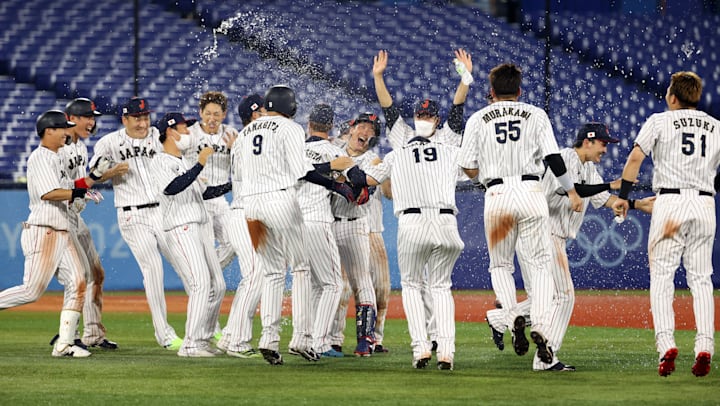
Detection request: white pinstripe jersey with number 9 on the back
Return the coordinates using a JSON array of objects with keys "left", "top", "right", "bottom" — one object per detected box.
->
[{"left": 235, "top": 116, "right": 314, "bottom": 196}]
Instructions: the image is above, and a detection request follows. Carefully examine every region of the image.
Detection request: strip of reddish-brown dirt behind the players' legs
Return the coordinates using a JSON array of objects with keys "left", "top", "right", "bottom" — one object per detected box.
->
[{"left": 9, "top": 292, "right": 720, "bottom": 330}]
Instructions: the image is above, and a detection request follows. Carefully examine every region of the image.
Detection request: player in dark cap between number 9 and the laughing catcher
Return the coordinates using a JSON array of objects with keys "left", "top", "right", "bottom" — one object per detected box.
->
[{"left": 298, "top": 104, "right": 354, "bottom": 357}]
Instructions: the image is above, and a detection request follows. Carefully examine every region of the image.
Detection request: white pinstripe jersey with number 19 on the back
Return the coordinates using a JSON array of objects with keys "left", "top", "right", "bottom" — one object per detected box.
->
[{"left": 385, "top": 137, "right": 460, "bottom": 216}]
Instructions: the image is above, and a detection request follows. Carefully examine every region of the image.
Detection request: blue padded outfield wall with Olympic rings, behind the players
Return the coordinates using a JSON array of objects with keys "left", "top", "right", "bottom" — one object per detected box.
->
[{"left": 0, "top": 190, "right": 720, "bottom": 290}]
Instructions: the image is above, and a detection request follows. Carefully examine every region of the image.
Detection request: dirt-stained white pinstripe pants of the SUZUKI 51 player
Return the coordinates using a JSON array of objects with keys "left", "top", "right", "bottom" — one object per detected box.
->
[{"left": 648, "top": 190, "right": 716, "bottom": 355}]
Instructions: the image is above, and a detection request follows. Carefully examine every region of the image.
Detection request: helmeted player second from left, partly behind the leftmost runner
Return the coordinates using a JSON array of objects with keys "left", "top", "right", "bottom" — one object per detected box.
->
[{"left": 48, "top": 98, "right": 128, "bottom": 350}]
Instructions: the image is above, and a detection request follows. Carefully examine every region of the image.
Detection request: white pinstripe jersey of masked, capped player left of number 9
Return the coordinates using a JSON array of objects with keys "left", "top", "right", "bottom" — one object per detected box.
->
[{"left": 150, "top": 152, "right": 209, "bottom": 231}]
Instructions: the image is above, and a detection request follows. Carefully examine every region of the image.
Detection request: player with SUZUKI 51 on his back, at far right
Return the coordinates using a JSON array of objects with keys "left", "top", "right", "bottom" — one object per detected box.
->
[{"left": 613, "top": 72, "right": 720, "bottom": 376}]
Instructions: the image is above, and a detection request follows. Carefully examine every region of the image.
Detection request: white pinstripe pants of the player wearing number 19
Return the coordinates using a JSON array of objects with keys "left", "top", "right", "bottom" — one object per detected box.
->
[{"left": 397, "top": 209, "right": 465, "bottom": 360}]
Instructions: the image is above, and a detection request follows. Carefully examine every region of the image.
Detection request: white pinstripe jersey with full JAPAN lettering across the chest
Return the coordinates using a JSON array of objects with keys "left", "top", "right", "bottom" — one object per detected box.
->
[{"left": 90, "top": 127, "right": 163, "bottom": 207}]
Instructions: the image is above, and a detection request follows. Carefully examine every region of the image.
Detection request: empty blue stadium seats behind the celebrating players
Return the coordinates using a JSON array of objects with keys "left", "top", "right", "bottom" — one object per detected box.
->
[{"left": 0, "top": 0, "right": 708, "bottom": 183}]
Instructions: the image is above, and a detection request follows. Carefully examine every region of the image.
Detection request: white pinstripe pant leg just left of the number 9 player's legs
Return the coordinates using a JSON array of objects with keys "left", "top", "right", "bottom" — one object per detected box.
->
[{"left": 219, "top": 208, "right": 264, "bottom": 352}]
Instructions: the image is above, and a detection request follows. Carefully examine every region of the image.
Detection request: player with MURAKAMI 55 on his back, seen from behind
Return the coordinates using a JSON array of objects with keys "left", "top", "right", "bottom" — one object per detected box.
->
[{"left": 458, "top": 63, "right": 582, "bottom": 363}]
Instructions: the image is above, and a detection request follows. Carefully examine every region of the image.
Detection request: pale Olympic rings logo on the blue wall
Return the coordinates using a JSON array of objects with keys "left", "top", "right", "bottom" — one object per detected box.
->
[{"left": 567, "top": 214, "right": 644, "bottom": 269}]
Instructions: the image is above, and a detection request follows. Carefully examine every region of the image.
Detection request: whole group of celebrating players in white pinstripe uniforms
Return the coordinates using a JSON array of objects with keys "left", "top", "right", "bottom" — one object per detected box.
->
[{"left": 0, "top": 49, "right": 720, "bottom": 376}]
